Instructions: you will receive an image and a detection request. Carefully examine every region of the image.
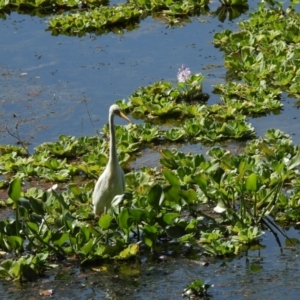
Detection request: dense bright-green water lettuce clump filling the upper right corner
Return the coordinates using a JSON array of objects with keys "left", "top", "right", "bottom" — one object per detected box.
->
[{"left": 214, "top": 3, "right": 300, "bottom": 94}]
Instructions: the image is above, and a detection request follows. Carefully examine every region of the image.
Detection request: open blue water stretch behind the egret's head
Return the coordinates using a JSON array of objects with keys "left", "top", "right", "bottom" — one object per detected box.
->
[{"left": 0, "top": 8, "right": 234, "bottom": 149}]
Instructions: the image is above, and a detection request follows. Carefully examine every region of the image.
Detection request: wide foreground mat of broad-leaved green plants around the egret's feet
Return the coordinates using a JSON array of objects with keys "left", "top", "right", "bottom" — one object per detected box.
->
[{"left": 0, "top": 130, "right": 300, "bottom": 278}]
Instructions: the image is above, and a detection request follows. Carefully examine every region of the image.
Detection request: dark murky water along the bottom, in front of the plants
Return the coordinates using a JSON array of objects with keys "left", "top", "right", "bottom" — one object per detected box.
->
[{"left": 0, "top": 230, "right": 300, "bottom": 300}]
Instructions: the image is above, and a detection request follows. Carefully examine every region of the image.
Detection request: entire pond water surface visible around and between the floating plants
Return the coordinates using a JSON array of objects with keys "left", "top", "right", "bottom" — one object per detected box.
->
[{"left": 0, "top": 2, "right": 300, "bottom": 299}]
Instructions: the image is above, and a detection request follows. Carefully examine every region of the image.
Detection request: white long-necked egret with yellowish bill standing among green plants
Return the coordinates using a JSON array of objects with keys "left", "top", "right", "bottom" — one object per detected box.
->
[{"left": 92, "top": 104, "right": 131, "bottom": 216}]
